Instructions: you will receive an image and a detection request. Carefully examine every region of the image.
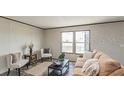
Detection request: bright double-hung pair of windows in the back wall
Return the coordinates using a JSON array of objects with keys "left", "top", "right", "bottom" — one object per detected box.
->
[{"left": 61, "top": 31, "right": 90, "bottom": 53}]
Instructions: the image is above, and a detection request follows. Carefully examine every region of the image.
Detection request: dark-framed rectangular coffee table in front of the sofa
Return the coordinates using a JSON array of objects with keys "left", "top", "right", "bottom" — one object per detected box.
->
[{"left": 48, "top": 59, "right": 69, "bottom": 76}]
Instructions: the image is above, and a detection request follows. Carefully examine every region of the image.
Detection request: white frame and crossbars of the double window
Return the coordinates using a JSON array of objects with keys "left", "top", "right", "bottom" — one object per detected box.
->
[{"left": 60, "top": 30, "right": 91, "bottom": 55}]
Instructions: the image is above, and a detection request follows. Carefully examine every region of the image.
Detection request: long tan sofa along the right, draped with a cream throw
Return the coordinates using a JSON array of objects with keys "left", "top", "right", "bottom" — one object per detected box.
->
[{"left": 74, "top": 50, "right": 124, "bottom": 76}]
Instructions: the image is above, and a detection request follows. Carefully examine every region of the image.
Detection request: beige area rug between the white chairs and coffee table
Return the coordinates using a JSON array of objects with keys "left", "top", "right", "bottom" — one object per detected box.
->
[{"left": 25, "top": 62, "right": 52, "bottom": 76}]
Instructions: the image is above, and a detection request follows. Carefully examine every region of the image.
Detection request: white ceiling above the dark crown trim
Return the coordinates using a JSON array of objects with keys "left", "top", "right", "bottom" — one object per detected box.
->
[{"left": 6, "top": 16, "right": 124, "bottom": 28}]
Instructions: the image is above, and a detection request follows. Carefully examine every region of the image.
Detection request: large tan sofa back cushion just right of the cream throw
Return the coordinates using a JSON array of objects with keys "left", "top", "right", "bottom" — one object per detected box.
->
[{"left": 99, "top": 54, "right": 121, "bottom": 76}]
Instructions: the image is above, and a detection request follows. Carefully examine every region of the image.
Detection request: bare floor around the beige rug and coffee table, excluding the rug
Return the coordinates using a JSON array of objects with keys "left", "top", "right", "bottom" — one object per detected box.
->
[{"left": 0, "top": 62, "right": 75, "bottom": 76}]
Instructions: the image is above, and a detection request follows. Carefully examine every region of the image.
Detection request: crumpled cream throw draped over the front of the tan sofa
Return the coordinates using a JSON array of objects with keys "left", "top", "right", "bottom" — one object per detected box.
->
[{"left": 82, "top": 59, "right": 99, "bottom": 76}]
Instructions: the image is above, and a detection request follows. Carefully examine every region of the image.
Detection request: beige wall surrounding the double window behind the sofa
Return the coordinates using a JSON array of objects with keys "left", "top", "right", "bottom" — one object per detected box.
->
[{"left": 45, "top": 22, "right": 124, "bottom": 64}]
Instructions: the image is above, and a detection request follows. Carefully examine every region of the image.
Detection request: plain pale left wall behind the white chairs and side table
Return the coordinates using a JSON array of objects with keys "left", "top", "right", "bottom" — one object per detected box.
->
[{"left": 0, "top": 18, "right": 44, "bottom": 73}]
